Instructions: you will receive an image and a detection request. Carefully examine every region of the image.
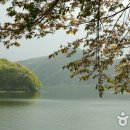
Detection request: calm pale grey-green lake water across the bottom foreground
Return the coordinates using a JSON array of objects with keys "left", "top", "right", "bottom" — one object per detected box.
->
[{"left": 0, "top": 93, "right": 130, "bottom": 130}]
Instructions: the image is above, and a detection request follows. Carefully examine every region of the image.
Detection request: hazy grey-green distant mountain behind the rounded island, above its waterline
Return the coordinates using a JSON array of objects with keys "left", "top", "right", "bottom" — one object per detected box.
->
[{"left": 18, "top": 49, "right": 119, "bottom": 86}]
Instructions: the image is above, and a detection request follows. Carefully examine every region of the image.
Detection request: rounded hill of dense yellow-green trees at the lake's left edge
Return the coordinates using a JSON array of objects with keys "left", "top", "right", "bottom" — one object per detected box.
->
[{"left": 0, "top": 59, "right": 41, "bottom": 93}]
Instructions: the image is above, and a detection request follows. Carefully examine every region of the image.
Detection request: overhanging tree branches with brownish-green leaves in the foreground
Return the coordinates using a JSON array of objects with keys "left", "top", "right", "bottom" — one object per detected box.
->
[{"left": 0, "top": 0, "right": 130, "bottom": 96}]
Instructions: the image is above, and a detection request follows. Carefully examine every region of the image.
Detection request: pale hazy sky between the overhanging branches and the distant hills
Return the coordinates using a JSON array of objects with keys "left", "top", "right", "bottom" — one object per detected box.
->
[{"left": 0, "top": 0, "right": 127, "bottom": 61}]
